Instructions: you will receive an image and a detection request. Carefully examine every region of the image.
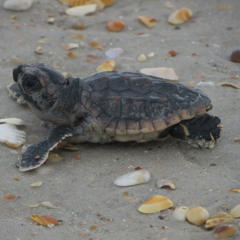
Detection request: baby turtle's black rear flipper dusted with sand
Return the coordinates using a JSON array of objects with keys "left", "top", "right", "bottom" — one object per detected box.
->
[{"left": 169, "top": 113, "right": 221, "bottom": 148}]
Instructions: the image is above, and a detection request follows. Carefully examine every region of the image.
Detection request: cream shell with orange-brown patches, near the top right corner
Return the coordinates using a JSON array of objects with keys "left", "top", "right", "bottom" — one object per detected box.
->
[{"left": 168, "top": 7, "right": 192, "bottom": 25}]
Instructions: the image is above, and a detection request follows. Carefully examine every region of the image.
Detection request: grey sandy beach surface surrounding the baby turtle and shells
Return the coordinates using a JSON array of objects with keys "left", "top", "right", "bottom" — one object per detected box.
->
[{"left": 0, "top": 0, "right": 240, "bottom": 240}]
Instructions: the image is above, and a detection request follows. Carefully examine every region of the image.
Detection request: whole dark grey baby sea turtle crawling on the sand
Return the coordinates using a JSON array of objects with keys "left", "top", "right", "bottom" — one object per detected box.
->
[{"left": 9, "top": 64, "right": 221, "bottom": 171}]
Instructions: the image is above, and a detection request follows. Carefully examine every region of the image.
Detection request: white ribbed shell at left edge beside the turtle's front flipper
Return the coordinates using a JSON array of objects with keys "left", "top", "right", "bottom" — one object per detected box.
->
[{"left": 0, "top": 123, "right": 26, "bottom": 148}]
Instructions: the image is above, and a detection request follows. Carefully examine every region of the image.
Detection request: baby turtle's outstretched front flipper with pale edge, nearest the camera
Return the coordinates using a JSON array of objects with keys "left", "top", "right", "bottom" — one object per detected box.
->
[{"left": 16, "top": 126, "right": 73, "bottom": 172}]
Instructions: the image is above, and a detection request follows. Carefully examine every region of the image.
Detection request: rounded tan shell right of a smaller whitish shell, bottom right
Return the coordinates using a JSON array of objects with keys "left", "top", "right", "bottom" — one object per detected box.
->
[{"left": 186, "top": 206, "right": 209, "bottom": 225}]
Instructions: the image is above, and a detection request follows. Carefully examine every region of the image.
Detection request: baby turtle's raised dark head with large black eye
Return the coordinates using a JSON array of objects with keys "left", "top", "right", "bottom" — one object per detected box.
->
[{"left": 13, "top": 63, "right": 68, "bottom": 121}]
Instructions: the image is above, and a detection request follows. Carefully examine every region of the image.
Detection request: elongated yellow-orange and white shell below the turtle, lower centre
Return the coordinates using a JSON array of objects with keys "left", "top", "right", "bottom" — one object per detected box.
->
[{"left": 138, "top": 195, "right": 173, "bottom": 213}]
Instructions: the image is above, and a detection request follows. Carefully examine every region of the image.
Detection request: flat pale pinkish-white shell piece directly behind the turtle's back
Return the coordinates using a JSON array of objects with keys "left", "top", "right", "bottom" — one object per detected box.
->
[{"left": 140, "top": 67, "right": 178, "bottom": 81}]
